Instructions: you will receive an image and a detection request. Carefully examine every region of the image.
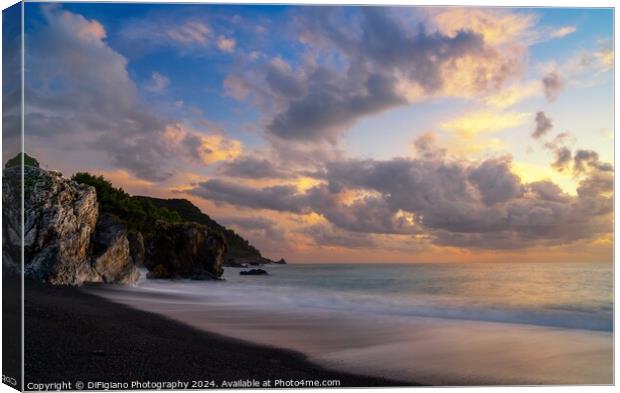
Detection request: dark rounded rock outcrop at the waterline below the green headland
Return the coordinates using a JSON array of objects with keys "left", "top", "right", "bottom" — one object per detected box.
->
[{"left": 144, "top": 221, "right": 227, "bottom": 279}]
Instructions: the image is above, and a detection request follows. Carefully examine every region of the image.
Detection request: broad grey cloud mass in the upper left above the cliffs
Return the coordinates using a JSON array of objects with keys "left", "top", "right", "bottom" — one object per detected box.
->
[{"left": 25, "top": 5, "right": 242, "bottom": 181}]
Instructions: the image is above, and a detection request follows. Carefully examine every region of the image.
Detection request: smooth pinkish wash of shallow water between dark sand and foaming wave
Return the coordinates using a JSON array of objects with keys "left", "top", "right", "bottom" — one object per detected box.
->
[{"left": 88, "top": 283, "right": 613, "bottom": 386}]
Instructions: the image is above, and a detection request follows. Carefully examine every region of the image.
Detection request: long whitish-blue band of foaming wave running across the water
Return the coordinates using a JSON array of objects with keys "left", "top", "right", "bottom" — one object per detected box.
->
[{"left": 130, "top": 279, "right": 613, "bottom": 331}]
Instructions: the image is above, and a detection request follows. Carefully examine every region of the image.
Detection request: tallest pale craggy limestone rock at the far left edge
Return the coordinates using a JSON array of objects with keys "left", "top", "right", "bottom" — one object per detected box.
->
[{"left": 2, "top": 166, "right": 98, "bottom": 285}]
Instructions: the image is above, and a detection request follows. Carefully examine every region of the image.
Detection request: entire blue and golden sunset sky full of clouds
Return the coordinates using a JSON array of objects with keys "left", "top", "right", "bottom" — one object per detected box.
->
[{"left": 3, "top": 3, "right": 614, "bottom": 263}]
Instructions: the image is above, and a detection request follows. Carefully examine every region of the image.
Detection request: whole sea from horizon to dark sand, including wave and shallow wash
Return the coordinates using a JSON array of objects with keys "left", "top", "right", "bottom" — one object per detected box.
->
[{"left": 88, "top": 262, "right": 614, "bottom": 386}]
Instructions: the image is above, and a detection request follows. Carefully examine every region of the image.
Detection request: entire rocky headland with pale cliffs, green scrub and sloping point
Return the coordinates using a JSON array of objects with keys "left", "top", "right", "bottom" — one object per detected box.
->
[{"left": 2, "top": 155, "right": 286, "bottom": 285}]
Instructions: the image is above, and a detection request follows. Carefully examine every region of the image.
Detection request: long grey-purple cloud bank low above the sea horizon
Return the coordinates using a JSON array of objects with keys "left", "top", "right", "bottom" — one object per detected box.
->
[{"left": 190, "top": 147, "right": 612, "bottom": 249}]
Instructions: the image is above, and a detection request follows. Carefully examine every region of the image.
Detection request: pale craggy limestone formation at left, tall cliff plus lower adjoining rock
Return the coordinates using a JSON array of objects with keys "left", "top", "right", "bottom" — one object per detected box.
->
[{"left": 2, "top": 166, "right": 138, "bottom": 285}]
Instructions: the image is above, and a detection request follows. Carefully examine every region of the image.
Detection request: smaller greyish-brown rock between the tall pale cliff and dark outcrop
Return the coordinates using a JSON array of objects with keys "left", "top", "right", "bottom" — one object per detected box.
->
[{"left": 91, "top": 214, "right": 140, "bottom": 284}]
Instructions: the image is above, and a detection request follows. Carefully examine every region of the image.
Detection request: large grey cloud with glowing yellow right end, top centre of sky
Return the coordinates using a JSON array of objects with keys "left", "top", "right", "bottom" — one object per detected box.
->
[{"left": 225, "top": 7, "right": 523, "bottom": 143}]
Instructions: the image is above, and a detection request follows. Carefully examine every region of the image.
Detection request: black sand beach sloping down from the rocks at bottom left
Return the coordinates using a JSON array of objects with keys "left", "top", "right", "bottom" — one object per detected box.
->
[{"left": 20, "top": 283, "right": 411, "bottom": 387}]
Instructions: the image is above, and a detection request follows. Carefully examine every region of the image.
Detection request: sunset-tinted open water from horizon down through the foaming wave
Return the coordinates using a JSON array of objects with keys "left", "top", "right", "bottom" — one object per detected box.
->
[{"left": 220, "top": 263, "right": 613, "bottom": 331}]
